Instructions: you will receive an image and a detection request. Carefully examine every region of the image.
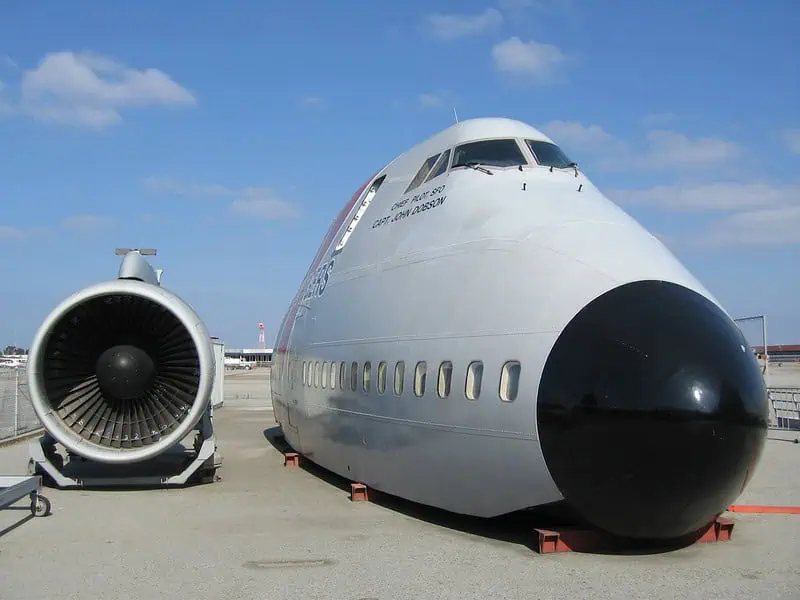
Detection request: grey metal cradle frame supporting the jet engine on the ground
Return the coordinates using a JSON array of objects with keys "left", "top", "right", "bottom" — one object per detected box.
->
[{"left": 28, "top": 405, "right": 222, "bottom": 489}]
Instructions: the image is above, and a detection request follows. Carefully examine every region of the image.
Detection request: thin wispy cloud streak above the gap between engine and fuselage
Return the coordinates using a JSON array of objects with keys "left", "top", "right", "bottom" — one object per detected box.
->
[{"left": 144, "top": 177, "right": 300, "bottom": 220}]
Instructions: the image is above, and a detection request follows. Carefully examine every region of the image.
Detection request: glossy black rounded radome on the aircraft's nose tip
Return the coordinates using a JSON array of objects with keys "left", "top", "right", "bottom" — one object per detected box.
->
[{"left": 537, "top": 281, "right": 769, "bottom": 539}]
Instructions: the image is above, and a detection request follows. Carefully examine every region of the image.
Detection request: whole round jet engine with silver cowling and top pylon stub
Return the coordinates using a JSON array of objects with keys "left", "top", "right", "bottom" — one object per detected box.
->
[{"left": 28, "top": 252, "right": 215, "bottom": 464}]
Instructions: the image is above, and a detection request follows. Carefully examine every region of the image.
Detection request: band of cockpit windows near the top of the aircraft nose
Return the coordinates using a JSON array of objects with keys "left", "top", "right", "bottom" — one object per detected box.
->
[{"left": 404, "top": 138, "right": 575, "bottom": 194}]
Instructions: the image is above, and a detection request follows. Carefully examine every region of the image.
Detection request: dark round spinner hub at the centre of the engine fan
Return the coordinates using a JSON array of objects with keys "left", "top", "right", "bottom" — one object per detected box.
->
[{"left": 95, "top": 345, "right": 156, "bottom": 400}]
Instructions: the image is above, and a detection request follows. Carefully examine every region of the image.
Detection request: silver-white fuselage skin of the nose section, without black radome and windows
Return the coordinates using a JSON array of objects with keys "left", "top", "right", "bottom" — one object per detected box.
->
[{"left": 272, "top": 119, "right": 720, "bottom": 516}]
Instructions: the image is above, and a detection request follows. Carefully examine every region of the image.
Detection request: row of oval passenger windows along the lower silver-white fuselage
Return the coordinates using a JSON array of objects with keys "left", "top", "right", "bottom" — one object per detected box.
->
[{"left": 296, "top": 360, "right": 521, "bottom": 402}]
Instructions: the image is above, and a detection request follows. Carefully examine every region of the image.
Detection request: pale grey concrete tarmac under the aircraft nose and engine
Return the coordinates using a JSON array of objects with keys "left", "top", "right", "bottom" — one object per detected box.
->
[{"left": 0, "top": 369, "right": 800, "bottom": 600}]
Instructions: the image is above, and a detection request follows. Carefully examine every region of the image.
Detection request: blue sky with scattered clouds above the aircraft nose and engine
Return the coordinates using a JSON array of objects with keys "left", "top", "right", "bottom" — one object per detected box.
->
[{"left": 0, "top": 0, "right": 800, "bottom": 346}]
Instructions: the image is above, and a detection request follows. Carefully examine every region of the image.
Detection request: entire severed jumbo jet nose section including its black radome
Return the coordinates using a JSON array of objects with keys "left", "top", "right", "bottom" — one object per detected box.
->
[{"left": 272, "top": 119, "right": 768, "bottom": 539}]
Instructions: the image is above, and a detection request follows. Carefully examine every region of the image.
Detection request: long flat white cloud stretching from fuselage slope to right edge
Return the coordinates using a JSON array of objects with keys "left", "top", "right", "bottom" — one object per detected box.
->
[{"left": 604, "top": 182, "right": 800, "bottom": 212}]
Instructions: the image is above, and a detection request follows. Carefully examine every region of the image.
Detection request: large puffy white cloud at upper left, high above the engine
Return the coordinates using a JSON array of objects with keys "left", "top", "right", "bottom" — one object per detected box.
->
[{"left": 20, "top": 52, "right": 196, "bottom": 129}]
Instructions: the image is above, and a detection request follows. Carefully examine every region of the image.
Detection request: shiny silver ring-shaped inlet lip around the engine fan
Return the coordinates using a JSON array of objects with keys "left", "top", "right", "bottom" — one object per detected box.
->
[{"left": 27, "top": 279, "right": 215, "bottom": 464}]
